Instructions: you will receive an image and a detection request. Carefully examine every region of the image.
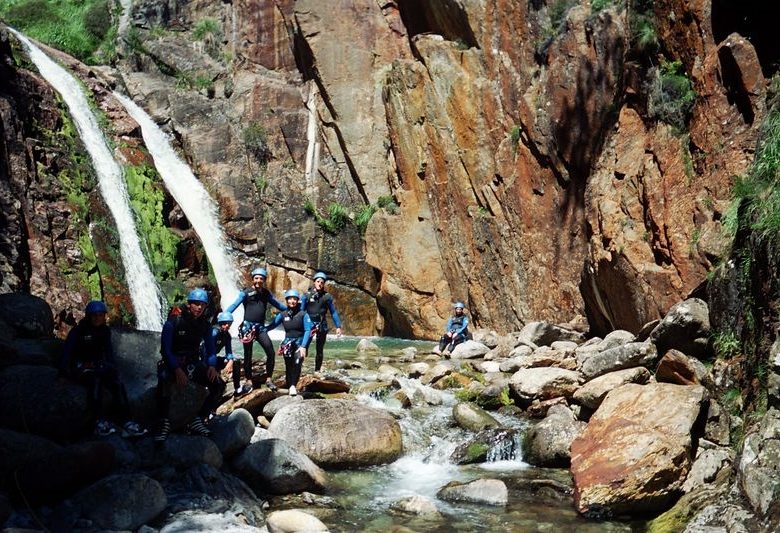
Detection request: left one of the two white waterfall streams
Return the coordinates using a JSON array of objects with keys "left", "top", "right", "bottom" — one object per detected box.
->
[{"left": 11, "top": 29, "right": 163, "bottom": 331}]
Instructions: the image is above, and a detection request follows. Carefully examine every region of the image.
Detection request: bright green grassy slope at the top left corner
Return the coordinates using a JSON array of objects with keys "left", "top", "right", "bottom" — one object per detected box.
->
[{"left": 0, "top": 0, "right": 116, "bottom": 64}]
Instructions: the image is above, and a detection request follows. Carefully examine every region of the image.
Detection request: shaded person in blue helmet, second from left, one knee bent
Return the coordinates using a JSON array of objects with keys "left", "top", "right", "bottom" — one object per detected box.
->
[{"left": 154, "top": 289, "right": 225, "bottom": 443}]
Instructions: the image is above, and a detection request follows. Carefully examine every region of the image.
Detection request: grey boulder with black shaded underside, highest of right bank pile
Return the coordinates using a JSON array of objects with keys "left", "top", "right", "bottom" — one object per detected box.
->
[{"left": 650, "top": 298, "right": 710, "bottom": 358}]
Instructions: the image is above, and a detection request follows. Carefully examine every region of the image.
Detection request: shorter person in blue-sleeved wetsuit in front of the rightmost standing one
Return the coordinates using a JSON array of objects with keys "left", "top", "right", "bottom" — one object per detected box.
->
[{"left": 268, "top": 289, "right": 313, "bottom": 396}]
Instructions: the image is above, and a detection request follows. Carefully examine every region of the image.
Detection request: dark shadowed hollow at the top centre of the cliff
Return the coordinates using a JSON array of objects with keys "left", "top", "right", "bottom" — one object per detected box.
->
[{"left": 398, "top": 0, "right": 479, "bottom": 48}]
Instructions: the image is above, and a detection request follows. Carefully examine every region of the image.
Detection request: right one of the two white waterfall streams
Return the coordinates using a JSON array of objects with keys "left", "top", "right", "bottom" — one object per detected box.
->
[{"left": 114, "top": 92, "right": 243, "bottom": 328}]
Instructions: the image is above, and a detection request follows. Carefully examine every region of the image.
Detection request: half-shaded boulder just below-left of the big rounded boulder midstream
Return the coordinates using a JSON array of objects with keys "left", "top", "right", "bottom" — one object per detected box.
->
[{"left": 231, "top": 438, "right": 326, "bottom": 494}]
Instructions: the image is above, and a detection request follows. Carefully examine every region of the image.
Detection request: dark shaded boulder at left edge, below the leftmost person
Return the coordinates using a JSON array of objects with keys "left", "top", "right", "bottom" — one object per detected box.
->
[{"left": 0, "top": 365, "right": 92, "bottom": 442}]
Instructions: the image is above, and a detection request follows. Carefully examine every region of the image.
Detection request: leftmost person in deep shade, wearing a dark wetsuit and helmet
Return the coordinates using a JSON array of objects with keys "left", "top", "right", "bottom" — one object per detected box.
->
[{"left": 60, "top": 300, "right": 147, "bottom": 438}]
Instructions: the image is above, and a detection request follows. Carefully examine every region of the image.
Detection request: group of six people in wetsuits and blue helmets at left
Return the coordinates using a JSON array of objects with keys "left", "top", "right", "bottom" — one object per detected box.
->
[{"left": 60, "top": 268, "right": 341, "bottom": 443}]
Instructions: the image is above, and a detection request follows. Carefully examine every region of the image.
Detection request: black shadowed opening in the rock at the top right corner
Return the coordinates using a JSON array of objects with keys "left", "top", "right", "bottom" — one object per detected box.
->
[{"left": 712, "top": 0, "right": 780, "bottom": 78}]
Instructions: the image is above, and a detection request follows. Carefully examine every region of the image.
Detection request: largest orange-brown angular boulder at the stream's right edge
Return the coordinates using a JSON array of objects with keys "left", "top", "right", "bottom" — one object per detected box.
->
[{"left": 571, "top": 383, "right": 707, "bottom": 515}]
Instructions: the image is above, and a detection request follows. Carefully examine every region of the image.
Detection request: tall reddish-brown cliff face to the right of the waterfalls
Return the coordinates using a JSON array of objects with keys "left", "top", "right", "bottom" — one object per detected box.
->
[{"left": 3, "top": 0, "right": 780, "bottom": 337}]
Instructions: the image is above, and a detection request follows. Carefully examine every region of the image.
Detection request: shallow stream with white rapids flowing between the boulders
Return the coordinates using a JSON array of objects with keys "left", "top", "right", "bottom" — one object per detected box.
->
[{"left": 273, "top": 337, "right": 644, "bottom": 533}]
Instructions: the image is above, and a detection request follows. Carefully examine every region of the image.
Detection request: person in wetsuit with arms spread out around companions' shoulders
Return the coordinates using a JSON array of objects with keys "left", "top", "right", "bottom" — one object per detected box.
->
[{"left": 227, "top": 268, "right": 285, "bottom": 396}]
